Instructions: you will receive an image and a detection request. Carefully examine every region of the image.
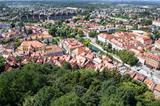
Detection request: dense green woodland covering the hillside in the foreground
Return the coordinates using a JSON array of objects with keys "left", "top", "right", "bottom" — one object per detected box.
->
[{"left": 0, "top": 63, "right": 160, "bottom": 106}]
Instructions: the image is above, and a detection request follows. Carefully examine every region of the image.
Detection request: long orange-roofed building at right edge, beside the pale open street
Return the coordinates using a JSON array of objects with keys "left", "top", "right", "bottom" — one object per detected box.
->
[{"left": 143, "top": 52, "right": 160, "bottom": 69}]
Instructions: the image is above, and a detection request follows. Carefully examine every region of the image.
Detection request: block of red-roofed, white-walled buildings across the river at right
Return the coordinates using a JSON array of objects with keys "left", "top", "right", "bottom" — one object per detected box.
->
[{"left": 97, "top": 32, "right": 160, "bottom": 69}]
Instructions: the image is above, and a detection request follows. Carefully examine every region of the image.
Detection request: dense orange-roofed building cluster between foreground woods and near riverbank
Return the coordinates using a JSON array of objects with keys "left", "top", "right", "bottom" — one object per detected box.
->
[{"left": 3, "top": 38, "right": 116, "bottom": 71}]
